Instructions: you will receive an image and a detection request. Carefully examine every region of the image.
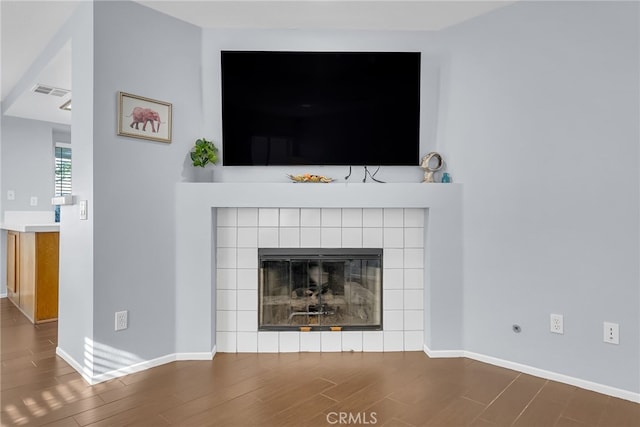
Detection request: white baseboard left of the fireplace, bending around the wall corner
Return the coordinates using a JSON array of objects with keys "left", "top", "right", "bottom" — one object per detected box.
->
[{"left": 56, "top": 346, "right": 216, "bottom": 385}]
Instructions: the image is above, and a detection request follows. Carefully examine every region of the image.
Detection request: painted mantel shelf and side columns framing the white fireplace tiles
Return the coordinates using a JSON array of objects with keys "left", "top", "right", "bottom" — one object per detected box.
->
[{"left": 175, "top": 182, "right": 463, "bottom": 359}]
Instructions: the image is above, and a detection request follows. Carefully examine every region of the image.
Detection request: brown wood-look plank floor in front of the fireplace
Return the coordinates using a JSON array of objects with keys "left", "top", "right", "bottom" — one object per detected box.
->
[{"left": 0, "top": 298, "right": 640, "bottom": 427}]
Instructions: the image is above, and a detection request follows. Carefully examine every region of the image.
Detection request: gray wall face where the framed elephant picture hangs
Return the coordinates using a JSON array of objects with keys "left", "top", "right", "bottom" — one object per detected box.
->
[{"left": 93, "top": 2, "right": 203, "bottom": 374}]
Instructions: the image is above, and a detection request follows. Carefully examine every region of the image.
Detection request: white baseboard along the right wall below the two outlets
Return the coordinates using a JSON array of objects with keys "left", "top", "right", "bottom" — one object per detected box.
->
[{"left": 424, "top": 344, "right": 640, "bottom": 403}]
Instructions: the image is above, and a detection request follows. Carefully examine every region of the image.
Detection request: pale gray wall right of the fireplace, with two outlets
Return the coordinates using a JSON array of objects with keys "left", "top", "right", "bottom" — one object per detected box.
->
[{"left": 441, "top": 2, "right": 640, "bottom": 393}]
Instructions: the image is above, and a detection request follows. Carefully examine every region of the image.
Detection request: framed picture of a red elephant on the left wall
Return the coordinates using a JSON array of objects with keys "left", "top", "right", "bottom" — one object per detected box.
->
[{"left": 118, "top": 92, "right": 171, "bottom": 143}]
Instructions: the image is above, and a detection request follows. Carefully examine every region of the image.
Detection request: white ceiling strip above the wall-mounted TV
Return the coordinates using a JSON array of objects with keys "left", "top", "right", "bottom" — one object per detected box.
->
[{"left": 138, "top": 0, "right": 512, "bottom": 31}]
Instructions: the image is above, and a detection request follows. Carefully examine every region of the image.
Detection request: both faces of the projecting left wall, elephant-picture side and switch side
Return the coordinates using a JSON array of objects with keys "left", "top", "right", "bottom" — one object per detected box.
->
[{"left": 58, "top": 2, "right": 202, "bottom": 377}]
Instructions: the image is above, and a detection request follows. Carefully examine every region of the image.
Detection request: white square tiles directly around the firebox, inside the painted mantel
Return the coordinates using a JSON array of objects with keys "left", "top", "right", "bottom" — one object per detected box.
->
[{"left": 216, "top": 208, "right": 425, "bottom": 353}]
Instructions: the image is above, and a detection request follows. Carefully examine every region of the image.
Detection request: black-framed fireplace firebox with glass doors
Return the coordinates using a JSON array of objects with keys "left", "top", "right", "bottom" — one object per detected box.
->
[{"left": 258, "top": 248, "right": 382, "bottom": 331}]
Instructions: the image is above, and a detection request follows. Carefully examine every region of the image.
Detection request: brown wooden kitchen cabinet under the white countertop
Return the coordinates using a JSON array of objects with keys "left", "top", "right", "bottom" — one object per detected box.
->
[{"left": 7, "top": 231, "right": 59, "bottom": 323}]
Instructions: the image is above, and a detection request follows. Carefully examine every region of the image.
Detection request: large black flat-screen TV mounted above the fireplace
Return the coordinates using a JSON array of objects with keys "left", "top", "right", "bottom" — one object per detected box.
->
[{"left": 221, "top": 51, "right": 420, "bottom": 166}]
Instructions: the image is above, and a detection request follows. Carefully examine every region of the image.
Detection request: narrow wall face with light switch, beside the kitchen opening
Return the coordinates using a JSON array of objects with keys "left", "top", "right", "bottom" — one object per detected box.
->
[{"left": 57, "top": 2, "right": 95, "bottom": 377}]
